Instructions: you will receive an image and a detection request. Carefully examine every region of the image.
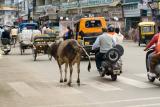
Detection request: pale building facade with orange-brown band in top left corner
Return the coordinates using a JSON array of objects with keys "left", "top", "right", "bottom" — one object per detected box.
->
[{"left": 0, "top": 0, "right": 16, "bottom": 25}]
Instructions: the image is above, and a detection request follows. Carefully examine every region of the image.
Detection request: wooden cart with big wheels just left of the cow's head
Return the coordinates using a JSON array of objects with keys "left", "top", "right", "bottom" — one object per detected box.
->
[{"left": 32, "top": 35, "right": 56, "bottom": 61}]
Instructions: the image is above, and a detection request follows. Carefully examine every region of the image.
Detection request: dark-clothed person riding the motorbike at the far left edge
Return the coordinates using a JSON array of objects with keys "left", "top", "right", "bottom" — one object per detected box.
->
[{"left": 1, "top": 27, "right": 11, "bottom": 45}]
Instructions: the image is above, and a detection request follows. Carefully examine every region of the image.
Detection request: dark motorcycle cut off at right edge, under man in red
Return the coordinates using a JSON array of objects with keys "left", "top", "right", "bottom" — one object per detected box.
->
[{"left": 146, "top": 46, "right": 160, "bottom": 82}]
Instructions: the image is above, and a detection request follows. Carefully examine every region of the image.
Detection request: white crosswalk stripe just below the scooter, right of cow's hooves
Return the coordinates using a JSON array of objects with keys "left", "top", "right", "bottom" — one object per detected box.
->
[{"left": 89, "top": 81, "right": 122, "bottom": 91}]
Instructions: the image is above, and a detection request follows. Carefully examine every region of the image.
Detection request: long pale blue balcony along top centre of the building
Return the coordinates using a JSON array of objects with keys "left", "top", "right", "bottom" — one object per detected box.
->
[{"left": 61, "top": 0, "right": 113, "bottom": 9}]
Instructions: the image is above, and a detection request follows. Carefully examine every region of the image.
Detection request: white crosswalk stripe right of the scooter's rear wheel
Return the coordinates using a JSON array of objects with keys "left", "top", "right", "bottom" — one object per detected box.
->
[{"left": 118, "top": 76, "right": 158, "bottom": 88}]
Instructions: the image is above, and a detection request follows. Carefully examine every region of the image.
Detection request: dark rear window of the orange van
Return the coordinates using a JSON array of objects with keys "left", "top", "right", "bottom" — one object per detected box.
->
[{"left": 85, "top": 20, "right": 102, "bottom": 28}]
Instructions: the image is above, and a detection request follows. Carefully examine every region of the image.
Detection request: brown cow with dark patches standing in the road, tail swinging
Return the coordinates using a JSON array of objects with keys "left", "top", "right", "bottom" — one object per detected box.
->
[{"left": 51, "top": 39, "right": 91, "bottom": 86}]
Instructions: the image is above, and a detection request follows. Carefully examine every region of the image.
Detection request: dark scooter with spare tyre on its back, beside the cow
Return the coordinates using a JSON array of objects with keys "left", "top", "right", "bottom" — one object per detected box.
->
[{"left": 99, "top": 45, "right": 124, "bottom": 81}]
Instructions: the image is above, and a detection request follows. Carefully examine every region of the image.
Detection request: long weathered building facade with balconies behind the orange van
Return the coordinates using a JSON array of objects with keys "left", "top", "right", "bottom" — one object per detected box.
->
[{"left": 33, "top": 0, "right": 124, "bottom": 26}]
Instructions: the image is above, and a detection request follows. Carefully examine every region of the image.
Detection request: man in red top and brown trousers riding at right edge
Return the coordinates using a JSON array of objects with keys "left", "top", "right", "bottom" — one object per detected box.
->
[{"left": 144, "top": 26, "right": 160, "bottom": 77}]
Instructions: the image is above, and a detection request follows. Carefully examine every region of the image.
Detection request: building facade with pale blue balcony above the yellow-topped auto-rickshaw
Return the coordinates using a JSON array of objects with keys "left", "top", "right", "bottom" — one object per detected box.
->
[{"left": 123, "top": 0, "right": 152, "bottom": 32}]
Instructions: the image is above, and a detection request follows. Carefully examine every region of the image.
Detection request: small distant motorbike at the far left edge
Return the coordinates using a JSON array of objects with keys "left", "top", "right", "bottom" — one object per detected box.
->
[{"left": 1, "top": 38, "right": 11, "bottom": 55}]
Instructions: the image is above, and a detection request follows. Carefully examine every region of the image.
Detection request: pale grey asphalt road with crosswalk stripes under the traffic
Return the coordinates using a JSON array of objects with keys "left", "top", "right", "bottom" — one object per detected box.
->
[{"left": 0, "top": 42, "right": 160, "bottom": 107}]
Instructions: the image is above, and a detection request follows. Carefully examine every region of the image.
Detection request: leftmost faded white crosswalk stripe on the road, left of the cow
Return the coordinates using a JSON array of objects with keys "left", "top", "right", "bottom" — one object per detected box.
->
[{"left": 8, "top": 82, "right": 40, "bottom": 97}]
